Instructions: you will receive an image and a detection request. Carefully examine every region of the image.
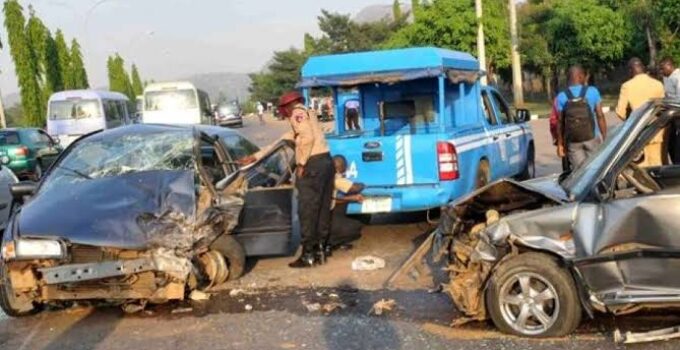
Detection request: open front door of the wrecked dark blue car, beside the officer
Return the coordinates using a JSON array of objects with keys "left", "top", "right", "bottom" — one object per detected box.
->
[{"left": 234, "top": 142, "right": 299, "bottom": 256}]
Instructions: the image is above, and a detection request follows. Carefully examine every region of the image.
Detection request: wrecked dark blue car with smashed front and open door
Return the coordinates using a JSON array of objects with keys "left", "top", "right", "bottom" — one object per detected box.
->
[{"left": 0, "top": 124, "right": 299, "bottom": 316}]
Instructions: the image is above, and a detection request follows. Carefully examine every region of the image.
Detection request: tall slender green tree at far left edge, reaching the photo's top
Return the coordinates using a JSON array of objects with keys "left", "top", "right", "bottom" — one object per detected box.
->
[{"left": 3, "top": 0, "right": 45, "bottom": 126}]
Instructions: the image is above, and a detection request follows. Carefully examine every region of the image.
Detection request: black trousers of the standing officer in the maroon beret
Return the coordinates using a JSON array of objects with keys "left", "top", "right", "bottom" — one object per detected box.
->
[{"left": 295, "top": 153, "right": 335, "bottom": 252}]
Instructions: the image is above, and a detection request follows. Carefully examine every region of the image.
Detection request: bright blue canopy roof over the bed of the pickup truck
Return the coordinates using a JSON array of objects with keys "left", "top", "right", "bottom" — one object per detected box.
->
[{"left": 299, "top": 47, "right": 479, "bottom": 87}]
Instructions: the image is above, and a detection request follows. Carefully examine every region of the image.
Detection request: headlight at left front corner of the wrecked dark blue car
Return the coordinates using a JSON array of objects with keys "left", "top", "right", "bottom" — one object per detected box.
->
[{"left": 2, "top": 239, "right": 66, "bottom": 260}]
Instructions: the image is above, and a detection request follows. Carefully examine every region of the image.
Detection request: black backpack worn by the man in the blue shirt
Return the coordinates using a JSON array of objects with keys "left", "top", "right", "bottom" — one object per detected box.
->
[{"left": 562, "top": 86, "right": 595, "bottom": 143}]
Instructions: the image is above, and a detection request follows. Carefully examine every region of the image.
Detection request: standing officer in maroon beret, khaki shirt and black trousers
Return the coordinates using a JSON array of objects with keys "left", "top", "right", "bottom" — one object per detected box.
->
[{"left": 279, "top": 91, "right": 335, "bottom": 268}]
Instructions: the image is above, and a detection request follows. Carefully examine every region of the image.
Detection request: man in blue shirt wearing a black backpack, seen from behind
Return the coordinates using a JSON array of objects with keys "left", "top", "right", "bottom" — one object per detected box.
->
[{"left": 557, "top": 65, "right": 607, "bottom": 170}]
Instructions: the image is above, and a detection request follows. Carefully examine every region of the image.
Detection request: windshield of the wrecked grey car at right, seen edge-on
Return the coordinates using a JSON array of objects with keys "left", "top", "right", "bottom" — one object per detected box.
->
[{"left": 561, "top": 103, "right": 651, "bottom": 199}]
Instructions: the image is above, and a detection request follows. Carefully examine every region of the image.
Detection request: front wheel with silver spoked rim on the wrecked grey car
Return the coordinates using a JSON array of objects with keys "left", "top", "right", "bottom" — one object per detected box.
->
[{"left": 486, "top": 253, "right": 581, "bottom": 337}]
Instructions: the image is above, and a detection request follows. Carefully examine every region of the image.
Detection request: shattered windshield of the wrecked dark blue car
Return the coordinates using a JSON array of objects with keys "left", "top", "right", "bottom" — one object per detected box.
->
[{"left": 41, "top": 130, "right": 195, "bottom": 192}]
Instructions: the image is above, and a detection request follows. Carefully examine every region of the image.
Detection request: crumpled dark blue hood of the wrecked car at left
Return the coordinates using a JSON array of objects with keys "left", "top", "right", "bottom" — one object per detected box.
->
[{"left": 13, "top": 170, "right": 196, "bottom": 249}]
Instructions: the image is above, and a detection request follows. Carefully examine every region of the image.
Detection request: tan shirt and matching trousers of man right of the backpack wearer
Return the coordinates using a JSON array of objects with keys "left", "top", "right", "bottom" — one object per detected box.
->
[{"left": 616, "top": 74, "right": 666, "bottom": 167}]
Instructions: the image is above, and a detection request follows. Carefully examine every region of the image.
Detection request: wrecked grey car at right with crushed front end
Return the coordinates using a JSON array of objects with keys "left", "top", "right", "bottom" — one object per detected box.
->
[{"left": 435, "top": 100, "right": 680, "bottom": 337}]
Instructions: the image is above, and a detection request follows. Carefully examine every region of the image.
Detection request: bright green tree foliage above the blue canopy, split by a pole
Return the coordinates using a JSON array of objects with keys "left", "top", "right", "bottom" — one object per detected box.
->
[{"left": 386, "top": 0, "right": 510, "bottom": 69}]
